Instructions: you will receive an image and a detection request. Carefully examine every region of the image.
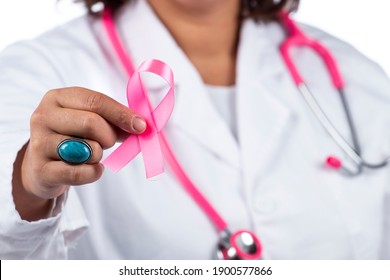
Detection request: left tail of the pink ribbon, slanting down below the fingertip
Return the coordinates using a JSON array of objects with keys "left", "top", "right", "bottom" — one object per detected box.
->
[{"left": 102, "top": 135, "right": 141, "bottom": 172}]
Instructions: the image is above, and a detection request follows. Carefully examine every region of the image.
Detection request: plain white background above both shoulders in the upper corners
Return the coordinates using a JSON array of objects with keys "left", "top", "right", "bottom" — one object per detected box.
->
[{"left": 0, "top": 0, "right": 390, "bottom": 74}]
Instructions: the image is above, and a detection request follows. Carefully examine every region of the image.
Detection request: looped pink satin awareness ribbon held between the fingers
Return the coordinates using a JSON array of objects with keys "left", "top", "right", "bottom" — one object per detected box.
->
[{"left": 102, "top": 59, "right": 174, "bottom": 178}]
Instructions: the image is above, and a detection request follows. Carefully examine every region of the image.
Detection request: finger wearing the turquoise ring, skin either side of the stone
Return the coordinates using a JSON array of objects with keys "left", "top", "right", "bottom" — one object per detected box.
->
[{"left": 45, "top": 133, "right": 103, "bottom": 164}]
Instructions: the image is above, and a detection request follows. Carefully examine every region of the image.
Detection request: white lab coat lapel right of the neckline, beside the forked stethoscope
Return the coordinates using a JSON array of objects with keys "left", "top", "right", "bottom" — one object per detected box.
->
[{"left": 237, "top": 20, "right": 291, "bottom": 186}]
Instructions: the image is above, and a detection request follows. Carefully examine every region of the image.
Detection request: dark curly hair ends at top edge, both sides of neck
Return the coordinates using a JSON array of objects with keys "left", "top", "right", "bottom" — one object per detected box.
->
[{"left": 76, "top": 0, "right": 299, "bottom": 20}]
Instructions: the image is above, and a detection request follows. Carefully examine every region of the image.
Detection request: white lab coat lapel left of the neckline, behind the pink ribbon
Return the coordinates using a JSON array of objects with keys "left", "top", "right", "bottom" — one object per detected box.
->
[{"left": 118, "top": 1, "right": 239, "bottom": 167}]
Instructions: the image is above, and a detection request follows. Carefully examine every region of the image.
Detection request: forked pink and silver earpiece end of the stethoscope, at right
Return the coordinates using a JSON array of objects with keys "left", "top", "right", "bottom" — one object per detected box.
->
[{"left": 280, "top": 13, "right": 390, "bottom": 176}]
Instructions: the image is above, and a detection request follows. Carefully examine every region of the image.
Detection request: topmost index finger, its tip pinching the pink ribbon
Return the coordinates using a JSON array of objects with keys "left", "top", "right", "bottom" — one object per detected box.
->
[{"left": 48, "top": 87, "right": 146, "bottom": 133}]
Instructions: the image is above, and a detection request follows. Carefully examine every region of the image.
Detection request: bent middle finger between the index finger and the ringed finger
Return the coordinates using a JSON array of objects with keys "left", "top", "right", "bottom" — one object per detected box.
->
[{"left": 42, "top": 108, "right": 117, "bottom": 149}]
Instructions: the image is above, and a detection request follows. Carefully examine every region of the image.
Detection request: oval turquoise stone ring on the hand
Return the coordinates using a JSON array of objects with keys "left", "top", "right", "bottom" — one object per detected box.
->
[{"left": 57, "top": 138, "right": 92, "bottom": 165}]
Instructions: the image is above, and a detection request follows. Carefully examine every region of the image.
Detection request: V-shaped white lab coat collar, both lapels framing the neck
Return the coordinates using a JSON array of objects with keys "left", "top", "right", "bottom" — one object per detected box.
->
[{"left": 117, "top": 1, "right": 287, "bottom": 171}]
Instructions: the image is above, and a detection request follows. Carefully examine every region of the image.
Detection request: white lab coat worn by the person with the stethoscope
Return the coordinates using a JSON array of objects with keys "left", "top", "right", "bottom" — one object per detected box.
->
[{"left": 0, "top": 1, "right": 390, "bottom": 259}]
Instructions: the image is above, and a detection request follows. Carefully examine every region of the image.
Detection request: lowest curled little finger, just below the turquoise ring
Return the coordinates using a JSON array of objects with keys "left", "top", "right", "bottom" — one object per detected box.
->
[{"left": 41, "top": 161, "right": 104, "bottom": 188}]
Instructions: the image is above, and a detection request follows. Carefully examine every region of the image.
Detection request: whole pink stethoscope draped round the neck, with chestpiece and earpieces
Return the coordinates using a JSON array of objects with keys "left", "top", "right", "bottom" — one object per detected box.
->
[{"left": 102, "top": 9, "right": 390, "bottom": 260}]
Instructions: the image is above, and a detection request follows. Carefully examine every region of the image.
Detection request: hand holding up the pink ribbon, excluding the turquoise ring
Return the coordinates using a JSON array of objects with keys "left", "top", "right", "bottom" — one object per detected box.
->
[{"left": 14, "top": 87, "right": 146, "bottom": 220}]
